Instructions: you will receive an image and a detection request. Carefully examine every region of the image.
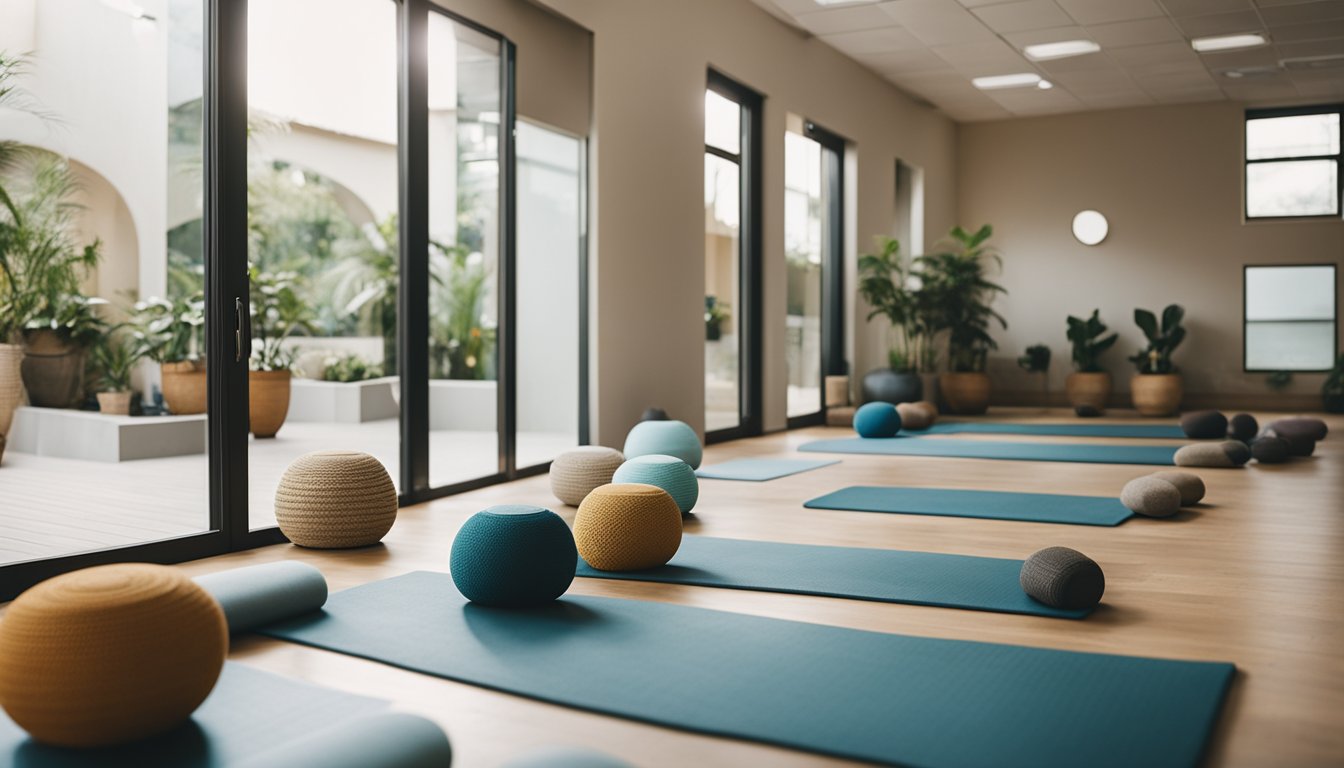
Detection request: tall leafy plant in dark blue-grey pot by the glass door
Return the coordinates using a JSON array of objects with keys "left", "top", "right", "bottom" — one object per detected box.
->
[{"left": 859, "top": 237, "right": 929, "bottom": 404}]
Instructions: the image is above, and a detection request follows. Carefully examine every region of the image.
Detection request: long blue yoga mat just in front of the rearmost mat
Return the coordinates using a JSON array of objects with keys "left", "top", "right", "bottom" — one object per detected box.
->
[{"left": 798, "top": 437, "right": 1176, "bottom": 467}]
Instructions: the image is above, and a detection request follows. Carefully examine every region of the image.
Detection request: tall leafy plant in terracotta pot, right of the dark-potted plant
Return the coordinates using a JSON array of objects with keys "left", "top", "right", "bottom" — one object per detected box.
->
[{"left": 915, "top": 225, "right": 1008, "bottom": 414}]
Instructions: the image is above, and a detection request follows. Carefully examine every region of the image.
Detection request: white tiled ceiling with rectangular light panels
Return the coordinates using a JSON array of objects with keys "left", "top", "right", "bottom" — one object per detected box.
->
[{"left": 754, "top": 0, "right": 1344, "bottom": 121}]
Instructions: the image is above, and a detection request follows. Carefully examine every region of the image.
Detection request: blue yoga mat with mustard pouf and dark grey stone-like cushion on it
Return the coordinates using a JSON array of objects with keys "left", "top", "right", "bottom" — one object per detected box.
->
[{"left": 578, "top": 537, "right": 1091, "bottom": 619}]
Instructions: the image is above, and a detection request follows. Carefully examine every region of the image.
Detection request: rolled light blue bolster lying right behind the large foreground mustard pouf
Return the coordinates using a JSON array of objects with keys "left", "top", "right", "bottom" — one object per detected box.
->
[{"left": 196, "top": 560, "right": 327, "bottom": 635}]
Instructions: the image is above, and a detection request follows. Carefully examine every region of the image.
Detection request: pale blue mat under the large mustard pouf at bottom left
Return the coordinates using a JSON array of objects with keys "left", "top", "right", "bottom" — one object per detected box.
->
[{"left": 0, "top": 662, "right": 387, "bottom": 768}]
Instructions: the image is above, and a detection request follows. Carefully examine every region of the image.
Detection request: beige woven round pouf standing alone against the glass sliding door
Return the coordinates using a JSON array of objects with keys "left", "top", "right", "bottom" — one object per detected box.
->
[{"left": 276, "top": 451, "right": 396, "bottom": 549}]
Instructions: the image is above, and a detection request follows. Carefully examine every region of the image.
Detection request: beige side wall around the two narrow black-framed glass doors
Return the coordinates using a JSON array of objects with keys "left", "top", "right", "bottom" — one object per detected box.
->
[{"left": 529, "top": 0, "right": 956, "bottom": 445}]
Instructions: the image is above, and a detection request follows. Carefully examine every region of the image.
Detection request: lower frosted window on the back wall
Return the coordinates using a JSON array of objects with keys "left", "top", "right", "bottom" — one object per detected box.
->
[{"left": 1243, "top": 264, "right": 1339, "bottom": 371}]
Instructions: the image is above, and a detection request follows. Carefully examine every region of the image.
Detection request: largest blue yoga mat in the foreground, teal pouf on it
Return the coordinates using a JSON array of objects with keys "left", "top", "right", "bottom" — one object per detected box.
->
[{"left": 265, "top": 572, "right": 1235, "bottom": 768}]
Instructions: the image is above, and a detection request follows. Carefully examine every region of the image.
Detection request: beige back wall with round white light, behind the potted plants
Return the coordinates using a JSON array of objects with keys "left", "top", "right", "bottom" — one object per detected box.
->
[{"left": 957, "top": 102, "right": 1344, "bottom": 408}]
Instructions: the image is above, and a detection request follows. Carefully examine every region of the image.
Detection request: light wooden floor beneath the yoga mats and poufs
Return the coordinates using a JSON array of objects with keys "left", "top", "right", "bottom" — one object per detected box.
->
[{"left": 47, "top": 410, "right": 1344, "bottom": 768}]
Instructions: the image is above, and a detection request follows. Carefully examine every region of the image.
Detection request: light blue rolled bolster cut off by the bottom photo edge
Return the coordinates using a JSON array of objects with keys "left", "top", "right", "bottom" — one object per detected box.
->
[{"left": 239, "top": 713, "right": 453, "bottom": 768}]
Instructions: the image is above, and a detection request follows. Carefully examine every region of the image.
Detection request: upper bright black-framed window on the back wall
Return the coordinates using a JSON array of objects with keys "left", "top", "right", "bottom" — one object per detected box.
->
[{"left": 1246, "top": 106, "right": 1341, "bottom": 219}]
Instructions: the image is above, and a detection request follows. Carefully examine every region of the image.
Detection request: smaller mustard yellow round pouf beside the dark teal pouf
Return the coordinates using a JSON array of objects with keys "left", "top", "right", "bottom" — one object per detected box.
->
[{"left": 574, "top": 483, "right": 681, "bottom": 570}]
